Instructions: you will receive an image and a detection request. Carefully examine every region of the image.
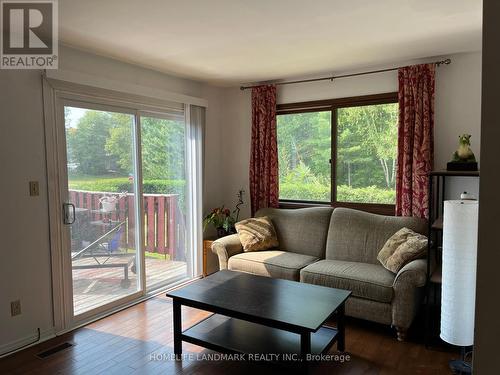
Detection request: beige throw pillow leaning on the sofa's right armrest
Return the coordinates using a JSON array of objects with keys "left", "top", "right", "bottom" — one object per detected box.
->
[{"left": 377, "top": 228, "right": 427, "bottom": 273}]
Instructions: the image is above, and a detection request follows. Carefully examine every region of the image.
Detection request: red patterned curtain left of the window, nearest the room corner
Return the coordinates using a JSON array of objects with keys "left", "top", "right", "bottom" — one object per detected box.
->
[{"left": 250, "top": 85, "right": 279, "bottom": 216}]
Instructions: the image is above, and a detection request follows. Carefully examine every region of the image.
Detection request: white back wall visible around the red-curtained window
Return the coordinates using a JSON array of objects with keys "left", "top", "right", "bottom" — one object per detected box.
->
[{"left": 219, "top": 52, "right": 481, "bottom": 215}]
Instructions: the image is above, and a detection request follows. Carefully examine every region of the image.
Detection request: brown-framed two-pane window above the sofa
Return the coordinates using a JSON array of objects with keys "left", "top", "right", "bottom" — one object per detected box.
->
[{"left": 277, "top": 93, "right": 398, "bottom": 213}]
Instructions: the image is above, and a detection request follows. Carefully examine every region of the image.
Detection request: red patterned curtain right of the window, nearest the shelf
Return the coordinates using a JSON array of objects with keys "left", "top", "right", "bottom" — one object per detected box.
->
[{"left": 396, "top": 64, "right": 435, "bottom": 218}]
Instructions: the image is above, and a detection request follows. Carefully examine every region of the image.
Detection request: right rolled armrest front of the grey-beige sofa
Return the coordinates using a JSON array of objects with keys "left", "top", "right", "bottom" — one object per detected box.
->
[{"left": 392, "top": 259, "right": 427, "bottom": 332}]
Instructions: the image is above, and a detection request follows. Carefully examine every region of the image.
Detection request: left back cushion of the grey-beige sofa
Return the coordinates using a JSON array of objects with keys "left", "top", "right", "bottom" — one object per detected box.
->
[{"left": 255, "top": 207, "right": 333, "bottom": 259}]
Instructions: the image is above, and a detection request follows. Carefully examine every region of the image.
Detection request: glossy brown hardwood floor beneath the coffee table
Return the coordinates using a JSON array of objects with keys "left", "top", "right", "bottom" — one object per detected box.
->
[{"left": 0, "top": 296, "right": 457, "bottom": 375}]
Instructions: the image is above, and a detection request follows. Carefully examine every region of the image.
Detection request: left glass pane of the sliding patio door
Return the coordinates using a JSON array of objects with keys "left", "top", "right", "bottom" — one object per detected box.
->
[{"left": 64, "top": 103, "right": 141, "bottom": 316}]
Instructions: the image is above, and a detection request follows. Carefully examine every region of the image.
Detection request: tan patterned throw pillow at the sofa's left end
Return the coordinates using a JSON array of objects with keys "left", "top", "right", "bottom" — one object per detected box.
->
[{"left": 235, "top": 216, "right": 278, "bottom": 251}]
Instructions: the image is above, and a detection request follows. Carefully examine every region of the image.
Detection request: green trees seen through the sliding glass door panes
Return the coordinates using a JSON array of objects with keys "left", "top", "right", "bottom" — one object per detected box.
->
[{"left": 65, "top": 107, "right": 185, "bottom": 180}]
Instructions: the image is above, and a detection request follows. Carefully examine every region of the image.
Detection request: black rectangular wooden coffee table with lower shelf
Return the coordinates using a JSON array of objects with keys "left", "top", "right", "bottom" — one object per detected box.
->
[{"left": 167, "top": 270, "right": 351, "bottom": 358}]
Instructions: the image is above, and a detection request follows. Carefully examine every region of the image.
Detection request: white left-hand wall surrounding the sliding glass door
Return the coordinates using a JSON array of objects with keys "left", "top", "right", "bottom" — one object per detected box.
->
[{"left": 0, "top": 47, "right": 223, "bottom": 353}]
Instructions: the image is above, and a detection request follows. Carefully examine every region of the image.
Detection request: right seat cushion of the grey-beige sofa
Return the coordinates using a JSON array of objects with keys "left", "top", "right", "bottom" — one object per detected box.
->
[{"left": 300, "top": 260, "right": 395, "bottom": 303}]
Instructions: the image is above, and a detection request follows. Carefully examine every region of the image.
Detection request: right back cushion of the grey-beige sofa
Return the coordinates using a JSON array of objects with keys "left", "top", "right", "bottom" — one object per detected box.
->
[{"left": 326, "top": 207, "right": 427, "bottom": 264}]
